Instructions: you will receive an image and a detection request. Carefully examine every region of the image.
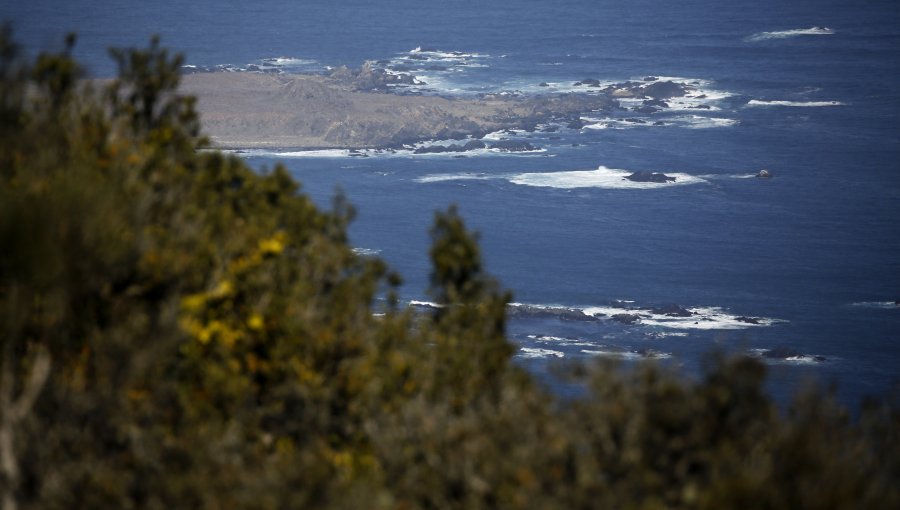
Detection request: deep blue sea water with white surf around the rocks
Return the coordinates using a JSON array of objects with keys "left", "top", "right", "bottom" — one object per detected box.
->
[{"left": 0, "top": 0, "right": 900, "bottom": 403}]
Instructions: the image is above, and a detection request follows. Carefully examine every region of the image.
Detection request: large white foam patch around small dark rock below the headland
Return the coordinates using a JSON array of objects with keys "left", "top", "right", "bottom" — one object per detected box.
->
[{"left": 508, "top": 166, "right": 706, "bottom": 189}]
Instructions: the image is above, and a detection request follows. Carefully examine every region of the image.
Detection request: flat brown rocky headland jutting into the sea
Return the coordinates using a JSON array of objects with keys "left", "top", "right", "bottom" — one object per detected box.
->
[{"left": 181, "top": 66, "right": 688, "bottom": 152}]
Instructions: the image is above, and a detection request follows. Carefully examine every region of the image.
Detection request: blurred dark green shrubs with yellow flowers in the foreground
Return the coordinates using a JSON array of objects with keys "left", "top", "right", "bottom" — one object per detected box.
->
[{"left": 0, "top": 30, "right": 900, "bottom": 510}]
